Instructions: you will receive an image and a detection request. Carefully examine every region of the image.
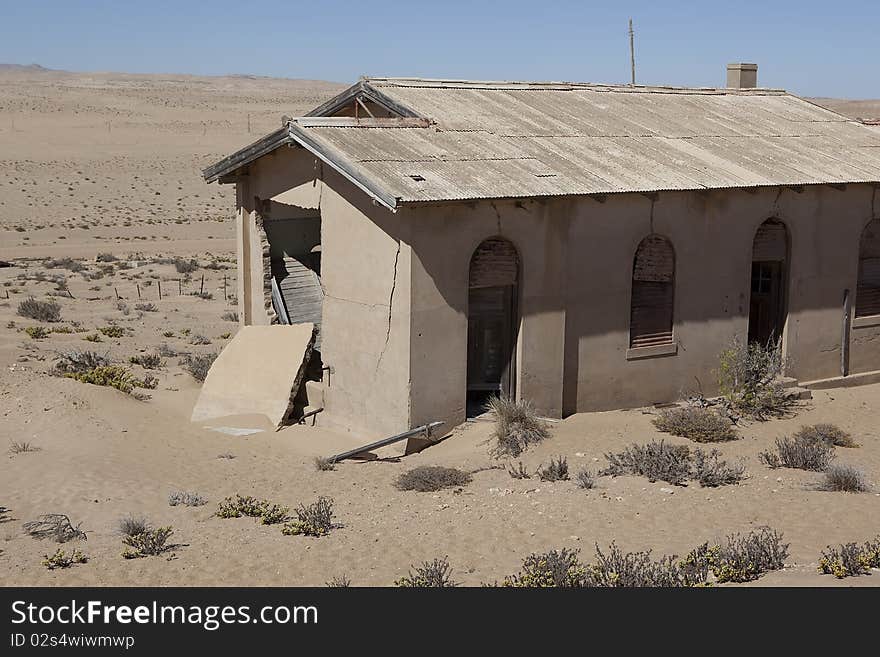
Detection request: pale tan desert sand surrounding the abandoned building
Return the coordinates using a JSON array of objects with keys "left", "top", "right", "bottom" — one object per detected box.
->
[{"left": 0, "top": 67, "right": 880, "bottom": 586}]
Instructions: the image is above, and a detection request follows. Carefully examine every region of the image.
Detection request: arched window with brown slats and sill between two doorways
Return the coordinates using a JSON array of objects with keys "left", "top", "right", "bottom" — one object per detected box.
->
[{"left": 629, "top": 235, "right": 675, "bottom": 347}]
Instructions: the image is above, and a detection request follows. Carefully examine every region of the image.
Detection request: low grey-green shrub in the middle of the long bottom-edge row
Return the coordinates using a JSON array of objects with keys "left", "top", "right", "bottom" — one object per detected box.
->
[{"left": 587, "top": 543, "right": 709, "bottom": 588}]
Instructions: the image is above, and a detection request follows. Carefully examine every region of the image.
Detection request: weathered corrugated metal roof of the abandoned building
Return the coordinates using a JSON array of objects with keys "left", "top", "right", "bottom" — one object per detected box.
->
[{"left": 208, "top": 78, "right": 880, "bottom": 207}]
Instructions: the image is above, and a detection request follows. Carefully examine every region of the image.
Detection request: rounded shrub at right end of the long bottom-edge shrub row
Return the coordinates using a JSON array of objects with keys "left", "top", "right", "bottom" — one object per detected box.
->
[{"left": 709, "top": 527, "right": 789, "bottom": 582}]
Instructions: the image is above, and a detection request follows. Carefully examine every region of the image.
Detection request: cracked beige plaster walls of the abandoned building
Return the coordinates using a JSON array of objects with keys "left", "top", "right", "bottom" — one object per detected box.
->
[{"left": 232, "top": 149, "right": 880, "bottom": 437}]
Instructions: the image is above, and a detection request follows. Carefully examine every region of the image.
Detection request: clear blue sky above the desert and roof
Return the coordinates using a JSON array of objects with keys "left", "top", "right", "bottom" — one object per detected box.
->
[{"left": 0, "top": 0, "right": 880, "bottom": 98}]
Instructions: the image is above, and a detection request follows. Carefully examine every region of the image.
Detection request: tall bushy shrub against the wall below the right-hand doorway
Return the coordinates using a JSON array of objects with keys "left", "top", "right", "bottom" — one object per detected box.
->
[{"left": 718, "top": 338, "right": 795, "bottom": 420}]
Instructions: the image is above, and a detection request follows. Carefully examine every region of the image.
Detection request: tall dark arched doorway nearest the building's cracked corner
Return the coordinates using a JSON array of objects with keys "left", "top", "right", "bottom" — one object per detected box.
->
[{"left": 467, "top": 237, "right": 519, "bottom": 417}]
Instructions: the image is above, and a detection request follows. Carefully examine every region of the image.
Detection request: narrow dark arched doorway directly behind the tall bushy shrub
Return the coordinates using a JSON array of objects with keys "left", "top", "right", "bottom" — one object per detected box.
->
[{"left": 749, "top": 220, "right": 788, "bottom": 345}]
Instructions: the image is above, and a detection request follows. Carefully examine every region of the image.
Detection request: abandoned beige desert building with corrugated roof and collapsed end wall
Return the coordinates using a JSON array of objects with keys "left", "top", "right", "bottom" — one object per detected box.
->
[{"left": 204, "top": 65, "right": 880, "bottom": 436}]
